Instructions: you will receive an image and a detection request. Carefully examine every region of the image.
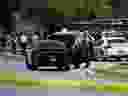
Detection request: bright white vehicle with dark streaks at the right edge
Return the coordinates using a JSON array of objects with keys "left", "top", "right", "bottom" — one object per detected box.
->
[{"left": 95, "top": 31, "right": 128, "bottom": 61}]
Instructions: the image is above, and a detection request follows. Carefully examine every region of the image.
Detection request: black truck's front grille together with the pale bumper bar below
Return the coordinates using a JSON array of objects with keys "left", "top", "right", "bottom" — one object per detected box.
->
[{"left": 31, "top": 50, "right": 69, "bottom": 69}]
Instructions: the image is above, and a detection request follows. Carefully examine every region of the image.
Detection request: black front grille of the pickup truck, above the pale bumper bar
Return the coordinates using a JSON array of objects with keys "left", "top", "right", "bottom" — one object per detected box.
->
[{"left": 32, "top": 50, "right": 64, "bottom": 66}]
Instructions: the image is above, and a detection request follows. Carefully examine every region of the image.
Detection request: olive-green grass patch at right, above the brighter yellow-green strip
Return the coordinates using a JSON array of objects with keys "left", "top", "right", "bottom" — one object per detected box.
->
[{"left": 96, "top": 64, "right": 128, "bottom": 80}]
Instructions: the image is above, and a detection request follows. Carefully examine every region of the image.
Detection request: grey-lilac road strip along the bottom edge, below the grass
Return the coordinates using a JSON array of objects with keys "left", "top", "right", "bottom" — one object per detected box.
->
[{"left": 0, "top": 88, "right": 127, "bottom": 96}]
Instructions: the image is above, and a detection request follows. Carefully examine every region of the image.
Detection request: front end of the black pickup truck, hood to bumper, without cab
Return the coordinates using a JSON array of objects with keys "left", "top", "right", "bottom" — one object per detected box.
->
[{"left": 26, "top": 40, "right": 76, "bottom": 70}]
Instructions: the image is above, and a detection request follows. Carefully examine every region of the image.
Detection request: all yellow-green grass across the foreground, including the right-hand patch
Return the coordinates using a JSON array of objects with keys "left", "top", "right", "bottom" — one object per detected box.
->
[{"left": 0, "top": 65, "right": 128, "bottom": 93}]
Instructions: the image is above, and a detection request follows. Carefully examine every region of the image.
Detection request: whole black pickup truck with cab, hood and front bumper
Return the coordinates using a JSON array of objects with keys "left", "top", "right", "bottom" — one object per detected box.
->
[{"left": 26, "top": 32, "right": 94, "bottom": 70}]
